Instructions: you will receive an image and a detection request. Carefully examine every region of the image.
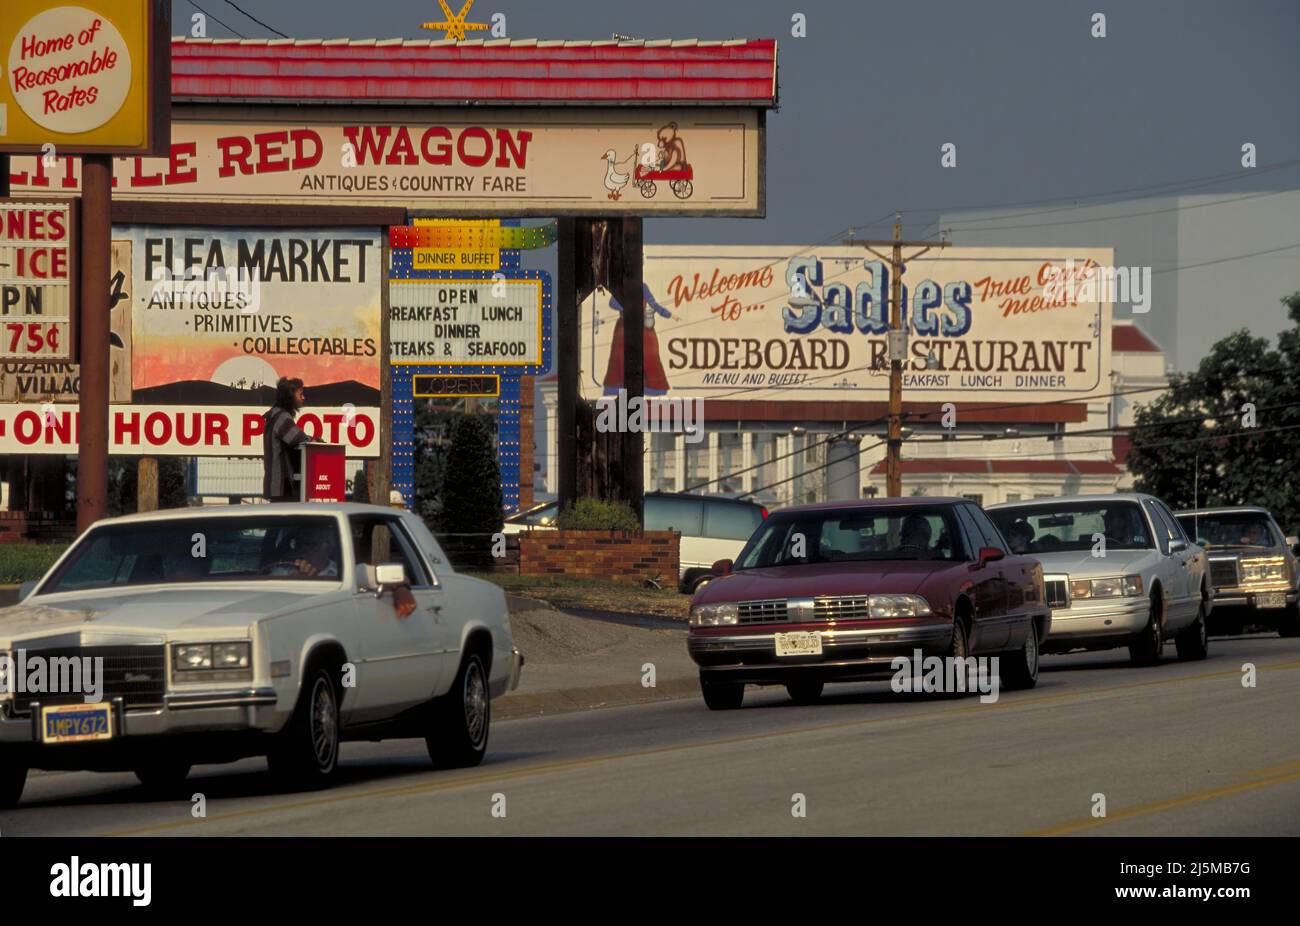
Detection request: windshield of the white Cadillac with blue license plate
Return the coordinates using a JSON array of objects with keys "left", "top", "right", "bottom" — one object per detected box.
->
[{"left": 38, "top": 515, "right": 343, "bottom": 594}]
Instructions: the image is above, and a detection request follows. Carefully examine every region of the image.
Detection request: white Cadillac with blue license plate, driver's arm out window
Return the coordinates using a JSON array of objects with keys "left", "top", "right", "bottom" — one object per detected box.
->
[{"left": 0, "top": 503, "right": 524, "bottom": 808}]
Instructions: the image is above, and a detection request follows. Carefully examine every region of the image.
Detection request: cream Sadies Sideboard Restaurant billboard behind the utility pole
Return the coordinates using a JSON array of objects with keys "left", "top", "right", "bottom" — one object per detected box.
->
[{"left": 582, "top": 246, "right": 1113, "bottom": 402}]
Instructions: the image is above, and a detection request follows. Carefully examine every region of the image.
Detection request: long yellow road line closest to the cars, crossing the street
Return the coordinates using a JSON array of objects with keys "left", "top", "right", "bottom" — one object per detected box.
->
[{"left": 101, "top": 661, "right": 1300, "bottom": 836}]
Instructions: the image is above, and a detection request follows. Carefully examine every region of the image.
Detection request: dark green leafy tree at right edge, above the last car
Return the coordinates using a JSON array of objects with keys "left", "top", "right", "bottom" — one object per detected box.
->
[{"left": 1128, "top": 293, "right": 1300, "bottom": 533}]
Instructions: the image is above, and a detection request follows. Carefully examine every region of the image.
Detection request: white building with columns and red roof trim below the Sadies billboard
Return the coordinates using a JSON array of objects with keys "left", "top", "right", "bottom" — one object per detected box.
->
[{"left": 536, "top": 323, "right": 1167, "bottom": 507}]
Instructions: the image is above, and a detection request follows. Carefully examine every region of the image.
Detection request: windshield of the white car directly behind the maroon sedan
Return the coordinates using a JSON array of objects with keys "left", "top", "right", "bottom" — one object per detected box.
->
[{"left": 988, "top": 501, "right": 1156, "bottom": 554}]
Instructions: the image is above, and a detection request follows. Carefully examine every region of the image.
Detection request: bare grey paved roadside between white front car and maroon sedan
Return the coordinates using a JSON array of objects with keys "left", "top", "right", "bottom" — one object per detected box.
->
[{"left": 493, "top": 596, "right": 699, "bottom": 721}]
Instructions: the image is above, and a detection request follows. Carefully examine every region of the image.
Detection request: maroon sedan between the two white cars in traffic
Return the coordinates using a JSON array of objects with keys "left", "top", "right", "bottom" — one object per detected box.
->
[{"left": 688, "top": 498, "right": 1052, "bottom": 710}]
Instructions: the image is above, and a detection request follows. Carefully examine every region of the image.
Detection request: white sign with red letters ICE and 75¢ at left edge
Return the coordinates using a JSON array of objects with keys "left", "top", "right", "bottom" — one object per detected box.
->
[{"left": 0, "top": 199, "right": 77, "bottom": 362}]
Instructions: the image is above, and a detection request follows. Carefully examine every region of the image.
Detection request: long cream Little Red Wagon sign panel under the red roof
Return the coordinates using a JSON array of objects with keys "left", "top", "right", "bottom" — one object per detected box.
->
[{"left": 13, "top": 108, "right": 763, "bottom": 217}]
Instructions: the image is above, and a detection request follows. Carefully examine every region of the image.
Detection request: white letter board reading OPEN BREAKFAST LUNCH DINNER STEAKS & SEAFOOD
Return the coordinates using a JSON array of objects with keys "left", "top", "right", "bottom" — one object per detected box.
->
[{"left": 389, "top": 280, "right": 542, "bottom": 365}]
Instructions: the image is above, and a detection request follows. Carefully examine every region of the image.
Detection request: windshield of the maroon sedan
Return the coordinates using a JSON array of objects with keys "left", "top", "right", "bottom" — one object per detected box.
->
[{"left": 735, "top": 505, "right": 967, "bottom": 570}]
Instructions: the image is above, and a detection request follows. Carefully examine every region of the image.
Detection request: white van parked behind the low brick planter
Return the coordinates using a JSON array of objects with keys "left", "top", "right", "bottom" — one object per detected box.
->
[{"left": 502, "top": 492, "right": 767, "bottom": 593}]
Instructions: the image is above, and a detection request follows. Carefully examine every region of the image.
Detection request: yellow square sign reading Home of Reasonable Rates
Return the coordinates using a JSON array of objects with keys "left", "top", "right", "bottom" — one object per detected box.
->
[{"left": 0, "top": 0, "right": 172, "bottom": 157}]
